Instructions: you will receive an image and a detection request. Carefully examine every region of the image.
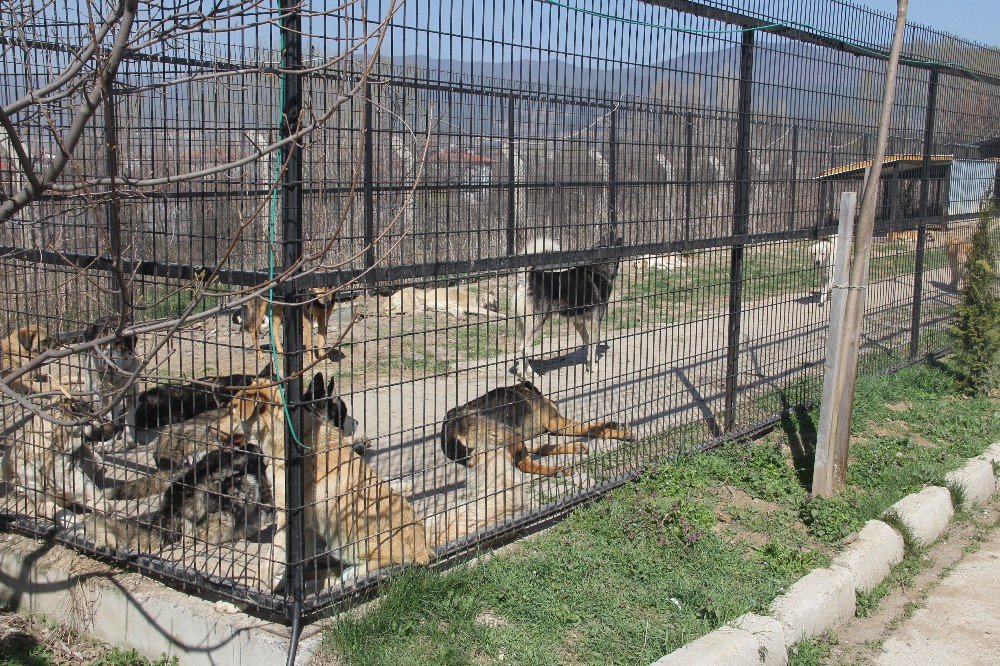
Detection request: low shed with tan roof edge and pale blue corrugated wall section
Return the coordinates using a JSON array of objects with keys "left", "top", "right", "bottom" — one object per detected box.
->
[{"left": 817, "top": 155, "right": 998, "bottom": 226}]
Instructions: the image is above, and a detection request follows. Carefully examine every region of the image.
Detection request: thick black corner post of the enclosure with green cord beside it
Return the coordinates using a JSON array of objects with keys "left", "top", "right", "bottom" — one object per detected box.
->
[{"left": 275, "top": 0, "right": 305, "bottom": 648}]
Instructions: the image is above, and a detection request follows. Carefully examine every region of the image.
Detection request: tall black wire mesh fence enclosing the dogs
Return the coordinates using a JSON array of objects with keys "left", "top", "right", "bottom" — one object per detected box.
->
[{"left": 0, "top": 0, "right": 1000, "bottom": 617}]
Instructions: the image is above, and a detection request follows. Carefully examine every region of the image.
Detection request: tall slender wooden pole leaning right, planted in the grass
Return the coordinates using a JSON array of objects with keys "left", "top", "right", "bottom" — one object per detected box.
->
[{"left": 812, "top": 0, "right": 908, "bottom": 496}]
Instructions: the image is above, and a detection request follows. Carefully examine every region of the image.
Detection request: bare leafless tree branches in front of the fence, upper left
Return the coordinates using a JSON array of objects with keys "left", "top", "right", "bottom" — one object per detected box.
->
[{"left": 0, "top": 0, "right": 428, "bottom": 425}]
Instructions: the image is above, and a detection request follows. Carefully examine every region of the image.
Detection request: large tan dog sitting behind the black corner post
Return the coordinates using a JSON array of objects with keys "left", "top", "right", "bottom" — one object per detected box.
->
[{"left": 219, "top": 376, "right": 434, "bottom": 587}]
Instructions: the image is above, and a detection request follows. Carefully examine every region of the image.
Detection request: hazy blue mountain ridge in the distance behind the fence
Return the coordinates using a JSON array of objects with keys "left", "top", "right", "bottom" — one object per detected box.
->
[{"left": 394, "top": 43, "right": 926, "bottom": 135}]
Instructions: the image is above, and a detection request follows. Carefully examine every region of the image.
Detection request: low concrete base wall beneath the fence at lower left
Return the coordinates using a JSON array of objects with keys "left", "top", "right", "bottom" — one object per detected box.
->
[{"left": 0, "top": 534, "right": 320, "bottom": 666}]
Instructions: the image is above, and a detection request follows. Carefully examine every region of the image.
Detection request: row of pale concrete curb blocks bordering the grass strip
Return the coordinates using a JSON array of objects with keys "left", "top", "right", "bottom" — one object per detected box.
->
[{"left": 651, "top": 442, "right": 1000, "bottom": 666}]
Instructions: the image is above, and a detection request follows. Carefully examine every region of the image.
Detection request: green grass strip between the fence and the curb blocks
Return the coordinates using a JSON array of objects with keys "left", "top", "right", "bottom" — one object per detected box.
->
[{"left": 326, "top": 366, "right": 1000, "bottom": 666}]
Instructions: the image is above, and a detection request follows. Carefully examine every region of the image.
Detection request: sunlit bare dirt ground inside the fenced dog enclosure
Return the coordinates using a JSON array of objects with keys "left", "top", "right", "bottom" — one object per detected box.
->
[{"left": 2, "top": 237, "right": 968, "bottom": 587}]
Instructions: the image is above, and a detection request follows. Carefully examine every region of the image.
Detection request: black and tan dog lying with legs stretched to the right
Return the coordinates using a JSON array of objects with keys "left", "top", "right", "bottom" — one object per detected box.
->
[{"left": 441, "top": 382, "right": 635, "bottom": 476}]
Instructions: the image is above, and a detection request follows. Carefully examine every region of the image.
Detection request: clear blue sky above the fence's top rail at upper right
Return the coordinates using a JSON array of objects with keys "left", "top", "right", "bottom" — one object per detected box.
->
[{"left": 855, "top": 0, "right": 1000, "bottom": 46}]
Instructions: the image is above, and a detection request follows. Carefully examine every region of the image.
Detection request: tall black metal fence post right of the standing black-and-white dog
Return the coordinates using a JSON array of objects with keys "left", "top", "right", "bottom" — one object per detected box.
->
[{"left": 723, "top": 30, "right": 754, "bottom": 432}]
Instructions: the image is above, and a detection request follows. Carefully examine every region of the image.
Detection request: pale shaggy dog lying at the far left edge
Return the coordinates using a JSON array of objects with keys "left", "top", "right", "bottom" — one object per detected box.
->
[{"left": 0, "top": 398, "right": 107, "bottom": 520}]
